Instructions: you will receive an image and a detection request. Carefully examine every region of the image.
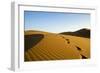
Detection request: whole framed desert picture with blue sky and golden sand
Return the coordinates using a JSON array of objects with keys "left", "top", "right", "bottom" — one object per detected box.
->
[{"left": 24, "top": 11, "right": 91, "bottom": 62}]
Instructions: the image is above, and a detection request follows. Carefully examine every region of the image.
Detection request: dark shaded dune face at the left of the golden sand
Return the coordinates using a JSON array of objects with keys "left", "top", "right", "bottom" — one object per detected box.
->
[{"left": 24, "top": 34, "right": 44, "bottom": 51}]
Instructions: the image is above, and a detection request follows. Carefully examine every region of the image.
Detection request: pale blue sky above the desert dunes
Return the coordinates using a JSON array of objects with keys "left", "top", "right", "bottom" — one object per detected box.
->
[{"left": 24, "top": 11, "right": 90, "bottom": 33}]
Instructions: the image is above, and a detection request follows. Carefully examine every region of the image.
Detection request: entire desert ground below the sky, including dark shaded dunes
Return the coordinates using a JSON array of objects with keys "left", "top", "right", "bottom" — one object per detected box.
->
[{"left": 24, "top": 28, "right": 90, "bottom": 62}]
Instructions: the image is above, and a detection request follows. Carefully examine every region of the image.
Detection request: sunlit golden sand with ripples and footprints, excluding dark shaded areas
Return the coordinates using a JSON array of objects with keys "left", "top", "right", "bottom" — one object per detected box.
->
[{"left": 24, "top": 31, "right": 90, "bottom": 62}]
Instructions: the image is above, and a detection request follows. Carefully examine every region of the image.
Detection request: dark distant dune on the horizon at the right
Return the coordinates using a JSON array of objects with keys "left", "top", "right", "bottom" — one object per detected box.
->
[{"left": 60, "top": 28, "right": 90, "bottom": 38}]
